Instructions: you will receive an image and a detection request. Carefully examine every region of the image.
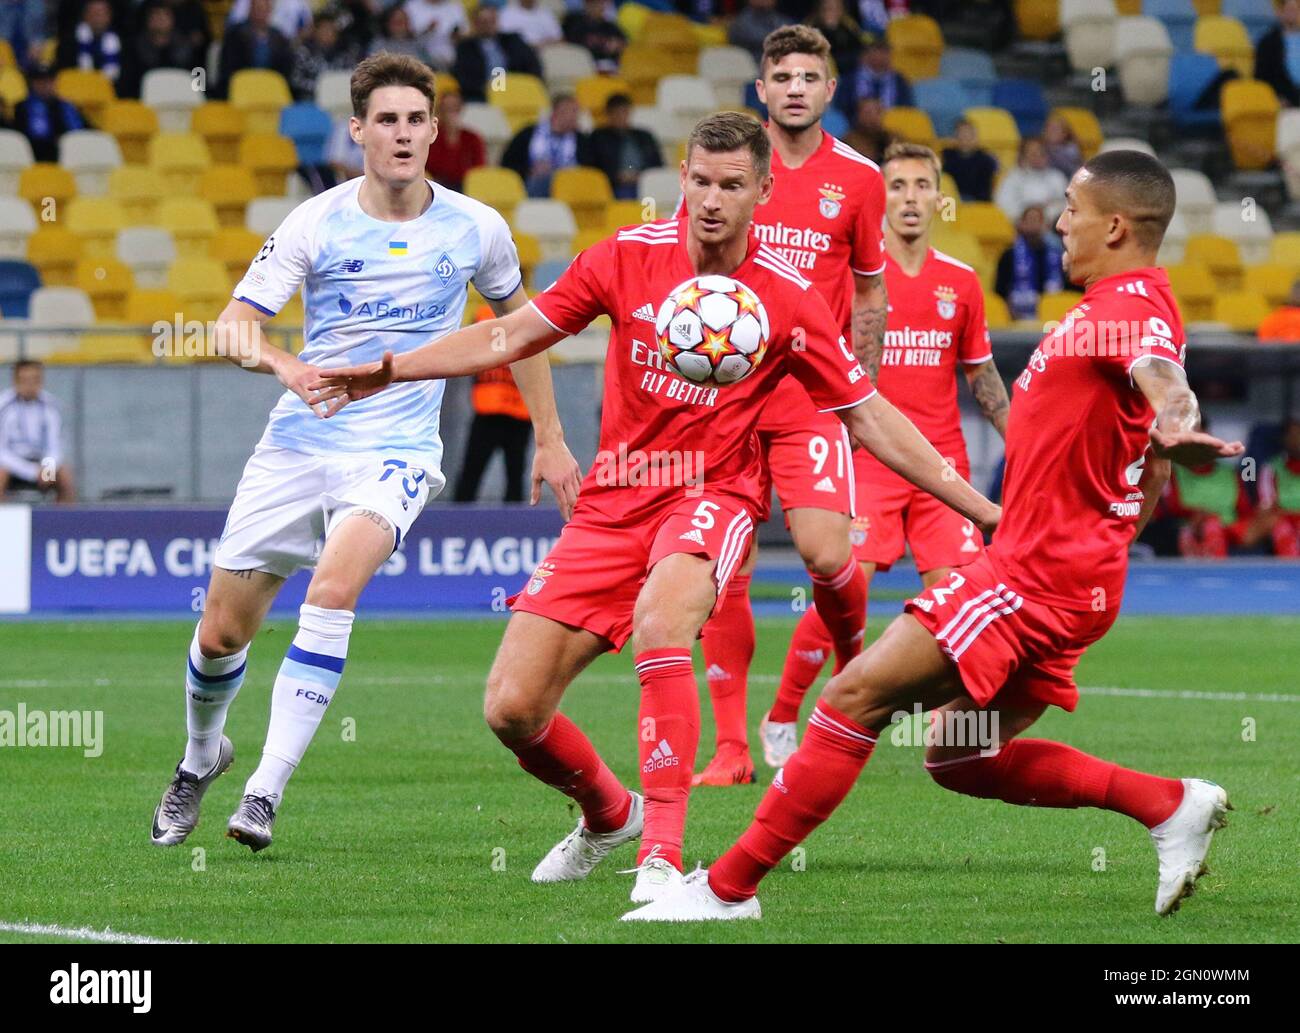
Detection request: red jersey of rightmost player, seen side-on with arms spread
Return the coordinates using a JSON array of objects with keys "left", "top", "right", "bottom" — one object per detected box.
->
[{"left": 989, "top": 268, "right": 1187, "bottom": 611}]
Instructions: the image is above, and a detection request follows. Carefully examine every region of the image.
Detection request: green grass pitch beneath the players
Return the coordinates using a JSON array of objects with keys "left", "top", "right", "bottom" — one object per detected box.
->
[{"left": 0, "top": 617, "right": 1300, "bottom": 943}]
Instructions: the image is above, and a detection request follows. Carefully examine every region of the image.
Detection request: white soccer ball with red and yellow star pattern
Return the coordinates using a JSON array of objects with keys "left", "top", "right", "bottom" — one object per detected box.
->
[{"left": 654, "top": 275, "right": 771, "bottom": 387}]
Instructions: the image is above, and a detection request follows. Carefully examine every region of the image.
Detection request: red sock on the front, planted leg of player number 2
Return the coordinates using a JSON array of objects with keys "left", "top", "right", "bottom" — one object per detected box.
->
[{"left": 709, "top": 699, "right": 876, "bottom": 900}]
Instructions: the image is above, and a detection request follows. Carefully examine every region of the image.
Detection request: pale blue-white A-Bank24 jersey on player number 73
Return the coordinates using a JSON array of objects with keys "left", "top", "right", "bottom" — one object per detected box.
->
[{"left": 234, "top": 177, "right": 521, "bottom": 470}]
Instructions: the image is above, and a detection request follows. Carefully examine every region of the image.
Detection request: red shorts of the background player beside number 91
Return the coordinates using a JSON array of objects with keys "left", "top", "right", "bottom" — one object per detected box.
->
[{"left": 852, "top": 448, "right": 984, "bottom": 573}]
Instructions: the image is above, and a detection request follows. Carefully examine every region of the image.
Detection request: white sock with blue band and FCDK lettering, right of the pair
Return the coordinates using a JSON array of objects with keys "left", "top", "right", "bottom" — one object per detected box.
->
[{"left": 244, "top": 603, "right": 356, "bottom": 808}]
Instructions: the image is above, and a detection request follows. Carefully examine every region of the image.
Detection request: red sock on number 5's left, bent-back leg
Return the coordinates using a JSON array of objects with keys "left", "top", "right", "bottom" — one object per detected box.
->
[{"left": 506, "top": 713, "right": 632, "bottom": 832}]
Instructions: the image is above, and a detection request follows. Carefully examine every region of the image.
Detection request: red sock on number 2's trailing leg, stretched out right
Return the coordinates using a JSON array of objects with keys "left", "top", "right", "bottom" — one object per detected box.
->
[{"left": 926, "top": 739, "right": 1183, "bottom": 829}]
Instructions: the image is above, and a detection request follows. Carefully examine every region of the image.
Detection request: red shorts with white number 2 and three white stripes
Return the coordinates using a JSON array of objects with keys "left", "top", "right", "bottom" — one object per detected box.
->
[{"left": 904, "top": 550, "right": 1118, "bottom": 711}]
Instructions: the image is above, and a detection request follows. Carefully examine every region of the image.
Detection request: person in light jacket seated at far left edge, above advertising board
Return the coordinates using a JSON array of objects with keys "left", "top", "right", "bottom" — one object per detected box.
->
[{"left": 0, "top": 359, "right": 77, "bottom": 503}]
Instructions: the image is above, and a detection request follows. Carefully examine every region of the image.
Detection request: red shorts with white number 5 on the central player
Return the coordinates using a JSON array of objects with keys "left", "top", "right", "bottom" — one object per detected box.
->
[{"left": 510, "top": 491, "right": 754, "bottom": 650}]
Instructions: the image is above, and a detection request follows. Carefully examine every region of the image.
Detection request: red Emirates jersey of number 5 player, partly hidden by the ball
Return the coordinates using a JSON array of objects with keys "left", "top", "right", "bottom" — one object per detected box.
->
[{"left": 532, "top": 218, "right": 875, "bottom": 524}]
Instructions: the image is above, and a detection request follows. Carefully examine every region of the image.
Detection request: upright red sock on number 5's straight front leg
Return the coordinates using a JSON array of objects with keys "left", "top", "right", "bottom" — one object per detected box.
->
[{"left": 636, "top": 648, "right": 699, "bottom": 871}]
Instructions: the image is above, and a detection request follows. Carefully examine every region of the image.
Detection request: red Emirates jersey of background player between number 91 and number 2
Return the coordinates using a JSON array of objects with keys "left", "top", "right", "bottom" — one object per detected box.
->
[{"left": 876, "top": 248, "right": 993, "bottom": 466}]
